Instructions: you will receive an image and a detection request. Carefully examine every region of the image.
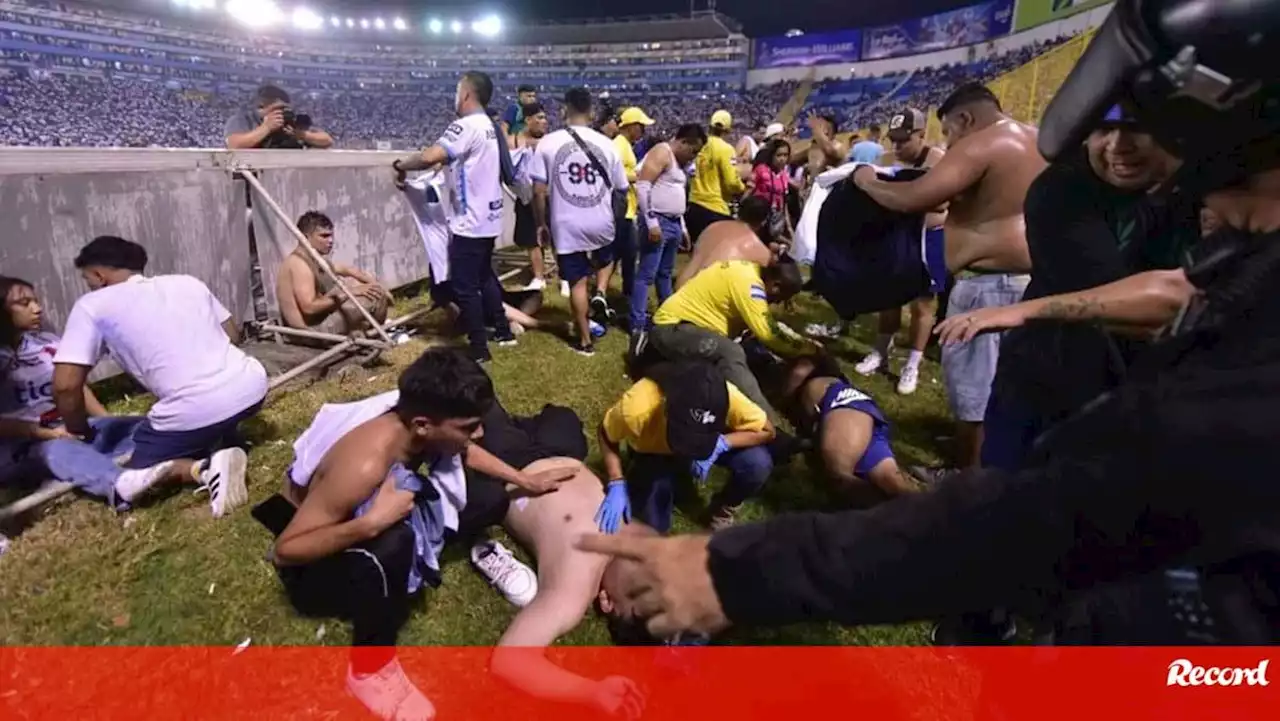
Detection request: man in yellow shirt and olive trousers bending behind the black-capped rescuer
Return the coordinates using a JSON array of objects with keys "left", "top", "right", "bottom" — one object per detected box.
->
[{"left": 641, "top": 259, "right": 818, "bottom": 424}]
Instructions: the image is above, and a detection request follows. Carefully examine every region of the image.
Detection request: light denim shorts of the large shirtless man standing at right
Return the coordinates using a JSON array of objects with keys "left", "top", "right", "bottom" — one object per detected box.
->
[{"left": 942, "top": 273, "right": 1032, "bottom": 423}]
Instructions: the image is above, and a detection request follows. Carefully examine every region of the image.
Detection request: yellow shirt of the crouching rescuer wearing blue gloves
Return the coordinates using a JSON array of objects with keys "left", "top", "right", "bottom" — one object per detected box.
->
[{"left": 604, "top": 378, "right": 769, "bottom": 456}]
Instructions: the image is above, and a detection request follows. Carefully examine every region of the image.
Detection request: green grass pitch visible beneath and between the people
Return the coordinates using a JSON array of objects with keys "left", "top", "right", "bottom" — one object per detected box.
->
[{"left": 0, "top": 283, "right": 950, "bottom": 645}]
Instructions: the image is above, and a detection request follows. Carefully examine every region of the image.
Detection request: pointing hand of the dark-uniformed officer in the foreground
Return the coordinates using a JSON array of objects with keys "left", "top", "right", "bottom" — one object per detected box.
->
[{"left": 576, "top": 535, "right": 730, "bottom": 638}]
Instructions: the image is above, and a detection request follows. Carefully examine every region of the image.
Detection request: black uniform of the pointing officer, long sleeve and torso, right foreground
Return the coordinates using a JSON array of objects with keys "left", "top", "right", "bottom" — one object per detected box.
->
[{"left": 708, "top": 232, "right": 1280, "bottom": 644}]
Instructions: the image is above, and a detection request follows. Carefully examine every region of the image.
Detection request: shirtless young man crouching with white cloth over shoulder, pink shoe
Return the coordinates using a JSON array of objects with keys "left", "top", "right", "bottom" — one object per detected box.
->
[{"left": 253, "top": 348, "right": 573, "bottom": 720}]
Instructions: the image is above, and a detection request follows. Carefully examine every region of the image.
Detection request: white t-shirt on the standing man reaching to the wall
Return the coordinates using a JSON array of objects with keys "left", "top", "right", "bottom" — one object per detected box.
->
[{"left": 436, "top": 113, "right": 503, "bottom": 238}]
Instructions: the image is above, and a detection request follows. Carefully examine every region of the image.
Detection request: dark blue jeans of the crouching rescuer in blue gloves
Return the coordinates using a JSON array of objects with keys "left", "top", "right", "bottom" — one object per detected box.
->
[{"left": 627, "top": 446, "right": 773, "bottom": 534}]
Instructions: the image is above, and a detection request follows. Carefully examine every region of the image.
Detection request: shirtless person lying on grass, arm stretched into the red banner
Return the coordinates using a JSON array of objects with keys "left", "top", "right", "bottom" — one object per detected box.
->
[{"left": 477, "top": 403, "right": 654, "bottom": 718}]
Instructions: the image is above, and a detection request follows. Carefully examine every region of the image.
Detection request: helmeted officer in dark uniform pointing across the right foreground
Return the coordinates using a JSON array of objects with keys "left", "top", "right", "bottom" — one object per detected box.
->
[{"left": 581, "top": 0, "right": 1280, "bottom": 645}]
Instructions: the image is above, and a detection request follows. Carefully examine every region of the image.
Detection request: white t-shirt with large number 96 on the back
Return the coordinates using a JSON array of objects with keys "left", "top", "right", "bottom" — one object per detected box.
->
[{"left": 529, "top": 126, "right": 628, "bottom": 255}]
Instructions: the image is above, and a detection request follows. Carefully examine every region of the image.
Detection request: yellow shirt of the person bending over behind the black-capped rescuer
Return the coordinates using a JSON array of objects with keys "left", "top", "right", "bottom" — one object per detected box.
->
[{"left": 653, "top": 260, "right": 817, "bottom": 356}]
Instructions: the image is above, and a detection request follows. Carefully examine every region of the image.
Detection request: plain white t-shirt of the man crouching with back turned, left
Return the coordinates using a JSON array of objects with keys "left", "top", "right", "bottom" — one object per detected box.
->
[{"left": 54, "top": 275, "right": 266, "bottom": 430}]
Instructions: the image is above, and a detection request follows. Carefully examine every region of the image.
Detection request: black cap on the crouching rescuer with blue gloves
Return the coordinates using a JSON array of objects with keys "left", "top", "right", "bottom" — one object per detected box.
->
[{"left": 649, "top": 361, "right": 728, "bottom": 460}]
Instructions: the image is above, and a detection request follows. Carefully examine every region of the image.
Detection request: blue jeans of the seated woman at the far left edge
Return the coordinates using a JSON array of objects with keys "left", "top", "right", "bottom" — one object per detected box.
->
[{"left": 22, "top": 416, "right": 145, "bottom": 506}]
